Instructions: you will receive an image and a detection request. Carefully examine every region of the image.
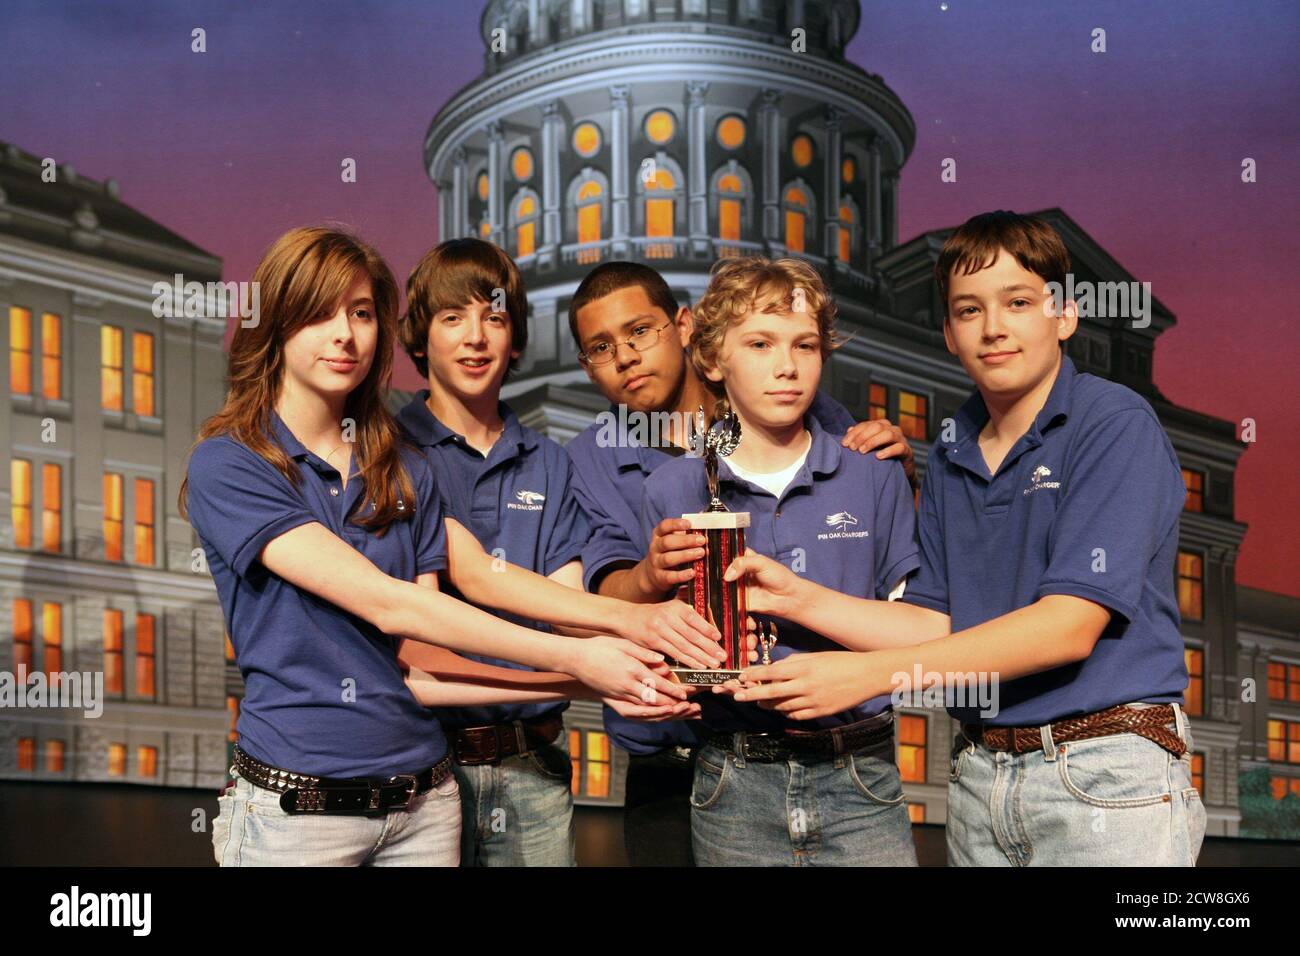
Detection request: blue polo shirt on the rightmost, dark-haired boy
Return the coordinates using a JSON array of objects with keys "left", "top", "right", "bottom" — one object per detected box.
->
[{"left": 902, "top": 356, "right": 1187, "bottom": 726}]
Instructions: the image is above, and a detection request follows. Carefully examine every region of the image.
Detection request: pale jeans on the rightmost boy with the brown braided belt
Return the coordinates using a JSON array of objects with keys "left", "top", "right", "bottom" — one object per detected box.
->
[{"left": 946, "top": 704, "right": 1205, "bottom": 866}]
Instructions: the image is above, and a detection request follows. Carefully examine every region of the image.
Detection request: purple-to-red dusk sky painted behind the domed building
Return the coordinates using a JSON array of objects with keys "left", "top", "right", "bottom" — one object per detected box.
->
[{"left": 0, "top": 0, "right": 1300, "bottom": 596}]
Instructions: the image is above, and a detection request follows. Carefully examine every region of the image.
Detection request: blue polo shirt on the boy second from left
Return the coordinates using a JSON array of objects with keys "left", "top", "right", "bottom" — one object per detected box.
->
[{"left": 398, "top": 389, "right": 588, "bottom": 728}]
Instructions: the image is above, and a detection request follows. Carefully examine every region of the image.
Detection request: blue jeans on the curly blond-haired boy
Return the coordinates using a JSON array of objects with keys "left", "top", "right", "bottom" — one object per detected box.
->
[{"left": 690, "top": 714, "right": 917, "bottom": 866}]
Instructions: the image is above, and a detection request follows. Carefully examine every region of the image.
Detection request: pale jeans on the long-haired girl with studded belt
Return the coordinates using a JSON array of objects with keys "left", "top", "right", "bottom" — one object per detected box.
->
[{"left": 212, "top": 767, "right": 460, "bottom": 866}]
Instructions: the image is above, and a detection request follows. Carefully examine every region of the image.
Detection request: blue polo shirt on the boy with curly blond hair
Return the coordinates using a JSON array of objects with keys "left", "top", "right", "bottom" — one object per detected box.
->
[{"left": 641, "top": 415, "right": 920, "bottom": 732}]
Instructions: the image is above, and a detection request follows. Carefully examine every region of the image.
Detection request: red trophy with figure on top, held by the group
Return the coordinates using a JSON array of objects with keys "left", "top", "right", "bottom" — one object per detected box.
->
[{"left": 671, "top": 408, "right": 749, "bottom": 687}]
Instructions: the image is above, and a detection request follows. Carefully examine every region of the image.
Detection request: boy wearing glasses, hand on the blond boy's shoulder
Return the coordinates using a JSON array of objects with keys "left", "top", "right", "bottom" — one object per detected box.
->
[{"left": 567, "top": 261, "right": 913, "bottom": 865}]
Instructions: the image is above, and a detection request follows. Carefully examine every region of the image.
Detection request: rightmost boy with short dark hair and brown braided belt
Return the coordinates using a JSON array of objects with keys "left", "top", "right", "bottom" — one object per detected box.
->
[{"left": 728, "top": 212, "right": 1205, "bottom": 866}]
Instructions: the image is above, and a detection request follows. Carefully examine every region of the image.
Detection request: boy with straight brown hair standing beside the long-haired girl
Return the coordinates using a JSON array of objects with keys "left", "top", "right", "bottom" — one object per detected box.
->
[{"left": 398, "top": 239, "right": 709, "bottom": 866}]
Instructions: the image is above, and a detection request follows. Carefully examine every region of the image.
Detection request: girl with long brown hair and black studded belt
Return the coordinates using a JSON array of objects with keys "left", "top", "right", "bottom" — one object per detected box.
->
[{"left": 181, "top": 228, "right": 690, "bottom": 865}]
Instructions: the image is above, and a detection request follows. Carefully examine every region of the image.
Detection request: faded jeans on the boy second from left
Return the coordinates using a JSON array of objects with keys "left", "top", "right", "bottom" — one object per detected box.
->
[{"left": 454, "top": 731, "right": 575, "bottom": 866}]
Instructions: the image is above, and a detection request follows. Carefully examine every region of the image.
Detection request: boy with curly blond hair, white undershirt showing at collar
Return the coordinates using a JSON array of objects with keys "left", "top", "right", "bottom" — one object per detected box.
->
[{"left": 641, "top": 258, "right": 919, "bottom": 866}]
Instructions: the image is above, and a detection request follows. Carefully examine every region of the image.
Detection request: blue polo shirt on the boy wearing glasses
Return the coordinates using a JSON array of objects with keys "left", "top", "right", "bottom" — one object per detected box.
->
[{"left": 566, "top": 392, "right": 857, "bottom": 756}]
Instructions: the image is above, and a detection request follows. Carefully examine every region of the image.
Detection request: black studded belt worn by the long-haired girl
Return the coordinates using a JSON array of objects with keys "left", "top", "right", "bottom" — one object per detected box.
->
[{"left": 234, "top": 747, "right": 451, "bottom": 817}]
